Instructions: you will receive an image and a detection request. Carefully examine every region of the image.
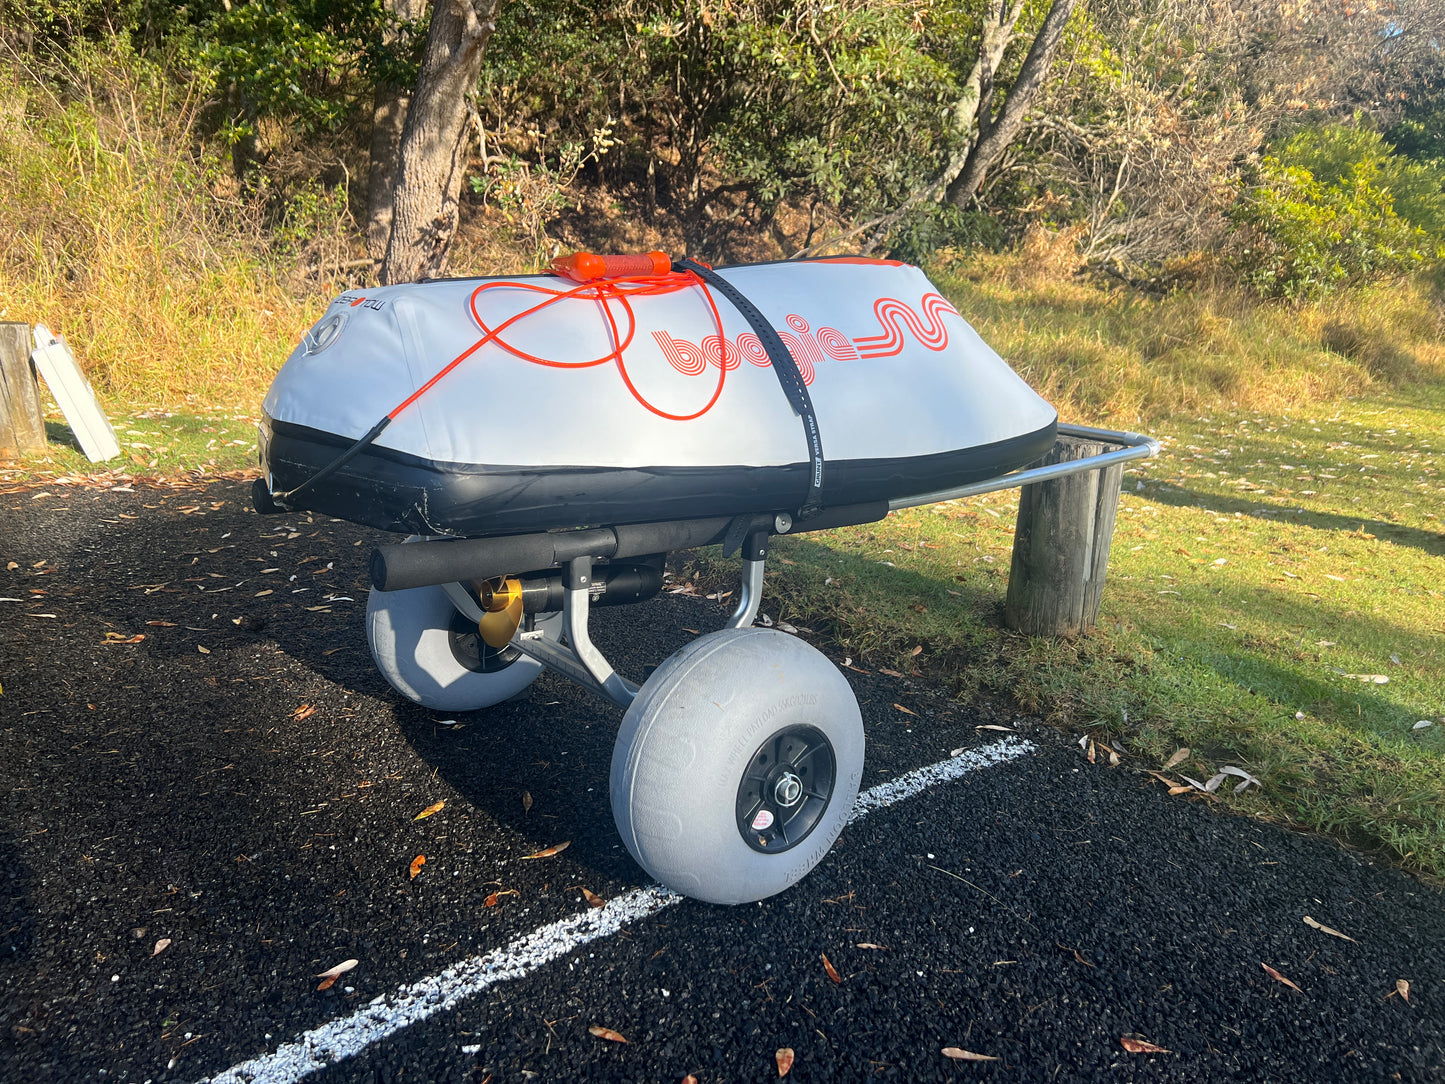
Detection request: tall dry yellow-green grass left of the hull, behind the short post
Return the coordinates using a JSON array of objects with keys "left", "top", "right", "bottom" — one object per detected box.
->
[{"left": 0, "top": 46, "right": 331, "bottom": 408}]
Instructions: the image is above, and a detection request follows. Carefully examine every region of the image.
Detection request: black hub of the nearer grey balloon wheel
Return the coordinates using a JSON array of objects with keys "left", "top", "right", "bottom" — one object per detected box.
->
[{"left": 737, "top": 726, "right": 838, "bottom": 854}]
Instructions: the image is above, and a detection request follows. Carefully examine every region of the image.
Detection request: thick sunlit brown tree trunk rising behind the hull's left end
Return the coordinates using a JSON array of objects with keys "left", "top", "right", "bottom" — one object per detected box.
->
[{"left": 379, "top": 0, "right": 497, "bottom": 283}]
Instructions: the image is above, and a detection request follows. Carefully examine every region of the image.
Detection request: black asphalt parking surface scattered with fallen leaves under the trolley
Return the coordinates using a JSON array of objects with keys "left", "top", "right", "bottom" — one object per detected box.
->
[{"left": 0, "top": 481, "right": 1445, "bottom": 1084}]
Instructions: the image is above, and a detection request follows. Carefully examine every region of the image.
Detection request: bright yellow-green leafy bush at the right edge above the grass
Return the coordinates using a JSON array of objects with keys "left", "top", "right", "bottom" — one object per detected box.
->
[{"left": 1234, "top": 124, "right": 1445, "bottom": 299}]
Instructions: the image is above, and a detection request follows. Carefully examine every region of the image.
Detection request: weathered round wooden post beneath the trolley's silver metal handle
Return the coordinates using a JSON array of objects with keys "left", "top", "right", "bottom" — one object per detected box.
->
[{"left": 1004, "top": 436, "right": 1124, "bottom": 636}]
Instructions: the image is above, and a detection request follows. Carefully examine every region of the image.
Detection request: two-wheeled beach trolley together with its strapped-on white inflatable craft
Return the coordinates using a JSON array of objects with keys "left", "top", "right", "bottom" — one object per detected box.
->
[{"left": 254, "top": 253, "right": 1157, "bottom": 903}]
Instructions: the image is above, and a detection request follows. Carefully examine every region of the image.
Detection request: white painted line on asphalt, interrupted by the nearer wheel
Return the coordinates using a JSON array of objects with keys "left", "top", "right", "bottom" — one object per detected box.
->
[{"left": 199, "top": 737, "right": 1035, "bottom": 1084}]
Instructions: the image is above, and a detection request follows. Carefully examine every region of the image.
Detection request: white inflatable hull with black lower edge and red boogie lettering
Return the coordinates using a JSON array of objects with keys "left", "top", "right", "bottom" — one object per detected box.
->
[{"left": 262, "top": 259, "right": 1058, "bottom": 536}]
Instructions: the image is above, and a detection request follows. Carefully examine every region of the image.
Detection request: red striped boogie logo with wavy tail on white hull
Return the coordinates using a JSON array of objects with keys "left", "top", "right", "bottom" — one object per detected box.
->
[{"left": 652, "top": 293, "right": 959, "bottom": 384}]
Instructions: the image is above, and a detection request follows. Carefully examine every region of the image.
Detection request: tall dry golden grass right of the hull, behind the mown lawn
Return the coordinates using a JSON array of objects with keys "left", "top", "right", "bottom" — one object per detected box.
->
[{"left": 933, "top": 238, "right": 1445, "bottom": 425}]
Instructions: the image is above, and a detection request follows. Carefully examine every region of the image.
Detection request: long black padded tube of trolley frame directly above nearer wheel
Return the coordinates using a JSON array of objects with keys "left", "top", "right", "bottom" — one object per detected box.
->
[{"left": 371, "top": 500, "right": 889, "bottom": 591}]
